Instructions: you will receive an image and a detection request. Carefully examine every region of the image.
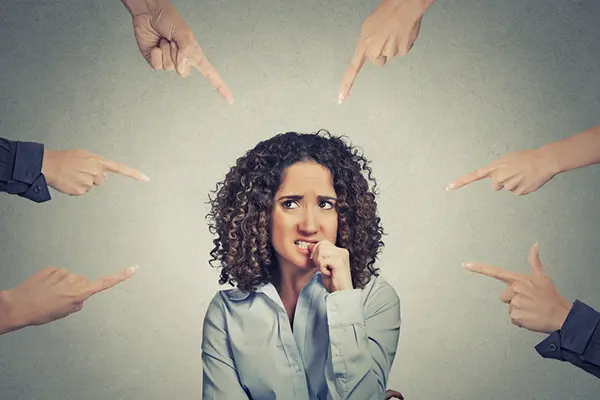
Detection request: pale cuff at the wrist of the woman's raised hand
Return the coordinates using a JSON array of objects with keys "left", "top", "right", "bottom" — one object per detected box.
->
[{"left": 326, "top": 289, "right": 365, "bottom": 326}]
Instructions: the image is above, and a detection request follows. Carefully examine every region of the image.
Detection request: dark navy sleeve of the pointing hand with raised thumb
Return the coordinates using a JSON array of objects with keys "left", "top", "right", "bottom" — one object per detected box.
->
[{"left": 535, "top": 300, "right": 600, "bottom": 378}]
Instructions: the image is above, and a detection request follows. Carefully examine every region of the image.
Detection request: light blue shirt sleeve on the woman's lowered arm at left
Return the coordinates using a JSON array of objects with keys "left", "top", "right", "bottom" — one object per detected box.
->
[{"left": 202, "top": 292, "right": 250, "bottom": 400}]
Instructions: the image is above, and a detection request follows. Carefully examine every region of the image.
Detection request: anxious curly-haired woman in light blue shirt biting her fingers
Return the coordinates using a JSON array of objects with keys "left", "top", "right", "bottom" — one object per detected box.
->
[{"left": 202, "top": 131, "right": 400, "bottom": 400}]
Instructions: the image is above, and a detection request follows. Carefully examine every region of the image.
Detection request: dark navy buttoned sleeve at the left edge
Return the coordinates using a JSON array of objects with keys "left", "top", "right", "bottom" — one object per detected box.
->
[{"left": 0, "top": 138, "right": 51, "bottom": 203}]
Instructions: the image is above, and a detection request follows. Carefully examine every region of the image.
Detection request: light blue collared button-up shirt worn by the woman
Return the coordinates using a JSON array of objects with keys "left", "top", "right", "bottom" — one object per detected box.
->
[{"left": 202, "top": 272, "right": 400, "bottom": 400}]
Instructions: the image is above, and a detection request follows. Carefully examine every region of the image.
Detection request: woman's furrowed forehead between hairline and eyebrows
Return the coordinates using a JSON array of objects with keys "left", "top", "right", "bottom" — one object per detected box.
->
[{"left": 278, "top": 161, "right": 335, "bottom": 195}]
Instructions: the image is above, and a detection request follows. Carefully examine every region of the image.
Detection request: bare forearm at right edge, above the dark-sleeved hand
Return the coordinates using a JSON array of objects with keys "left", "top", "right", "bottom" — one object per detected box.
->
[{"left": 540, "top": 125, "right": 600, "bottom": 174}]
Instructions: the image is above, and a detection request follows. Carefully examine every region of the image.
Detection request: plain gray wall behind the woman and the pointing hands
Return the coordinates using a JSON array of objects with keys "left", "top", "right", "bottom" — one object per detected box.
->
[{"left": 0, "top": 0, "right": 600, "bottom": 400}]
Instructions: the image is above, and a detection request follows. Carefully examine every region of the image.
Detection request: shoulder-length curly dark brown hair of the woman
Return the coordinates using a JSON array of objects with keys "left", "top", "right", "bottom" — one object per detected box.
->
[{"left": 206, "top": 129, "right": 384, "bottom": 292}]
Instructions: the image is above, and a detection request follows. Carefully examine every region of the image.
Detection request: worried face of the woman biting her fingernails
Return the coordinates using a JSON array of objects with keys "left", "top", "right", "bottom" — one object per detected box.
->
[{"left": 271, "top": 161, "right": 338, "bottom": 268}]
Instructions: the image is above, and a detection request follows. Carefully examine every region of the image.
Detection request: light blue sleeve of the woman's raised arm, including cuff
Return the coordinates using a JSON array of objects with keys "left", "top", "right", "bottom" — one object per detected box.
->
[{"left": 325, "top": 277, "right": 400, "bottom": 400}]
